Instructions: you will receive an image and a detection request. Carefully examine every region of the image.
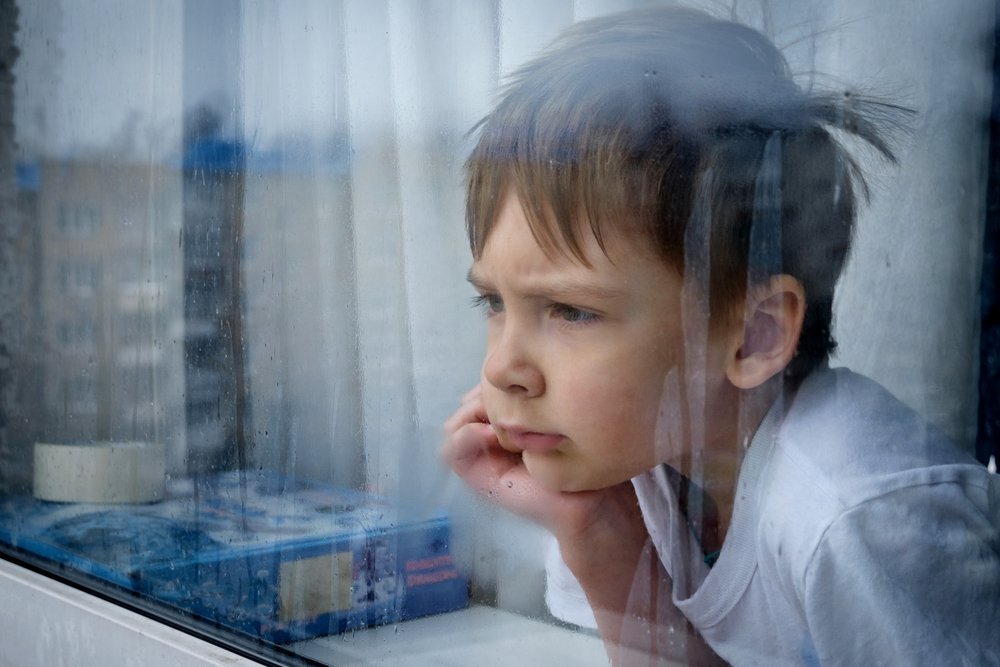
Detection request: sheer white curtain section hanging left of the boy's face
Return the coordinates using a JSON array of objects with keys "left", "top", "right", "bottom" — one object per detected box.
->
[{"left": 232, "top": 2, "right": 496, "bottom": 494}]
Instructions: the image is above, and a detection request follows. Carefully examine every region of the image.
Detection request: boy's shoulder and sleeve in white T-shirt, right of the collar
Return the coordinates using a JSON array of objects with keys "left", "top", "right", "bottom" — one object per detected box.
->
[{"left": 751, "top": 369, "right": 1000, "bottom": 664}]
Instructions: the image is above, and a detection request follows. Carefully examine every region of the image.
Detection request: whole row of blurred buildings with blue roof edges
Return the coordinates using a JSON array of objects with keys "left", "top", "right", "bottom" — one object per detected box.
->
[{"left": 6, "top": 137, "right": 366, "bottom": 482}]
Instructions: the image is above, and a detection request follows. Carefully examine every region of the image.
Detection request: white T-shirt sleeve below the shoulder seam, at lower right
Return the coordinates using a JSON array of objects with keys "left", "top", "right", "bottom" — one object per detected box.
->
[{"left": 803, "top": 482, "right": 1000, "bottom": 665}]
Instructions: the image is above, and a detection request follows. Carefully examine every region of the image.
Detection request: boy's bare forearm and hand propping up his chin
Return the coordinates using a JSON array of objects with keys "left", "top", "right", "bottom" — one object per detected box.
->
[{"left": 441, "top": 391, "right": 717, "bottom": 664}]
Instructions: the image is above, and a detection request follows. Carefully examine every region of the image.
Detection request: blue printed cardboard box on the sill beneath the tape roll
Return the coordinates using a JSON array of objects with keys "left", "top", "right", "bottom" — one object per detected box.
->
[{"left": 0, "top": 472, "right": 468, "bottom": 643}]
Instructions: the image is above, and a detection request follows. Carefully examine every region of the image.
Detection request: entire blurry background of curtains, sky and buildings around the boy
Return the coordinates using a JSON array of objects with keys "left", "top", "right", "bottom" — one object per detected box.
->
[{"left": 0, "top": 0, "right": 995, "bottom": 624}]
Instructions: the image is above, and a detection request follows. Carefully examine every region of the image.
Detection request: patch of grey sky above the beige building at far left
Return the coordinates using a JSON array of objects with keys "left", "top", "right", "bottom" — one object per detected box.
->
[{"left": 15, "top": 0, "right": 183, "bottom": 159}]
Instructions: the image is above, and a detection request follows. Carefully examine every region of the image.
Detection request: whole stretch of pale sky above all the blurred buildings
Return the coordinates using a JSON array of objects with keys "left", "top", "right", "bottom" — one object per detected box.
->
[{"left": 15, "top": 0, "right": 356, "bottom": 159}]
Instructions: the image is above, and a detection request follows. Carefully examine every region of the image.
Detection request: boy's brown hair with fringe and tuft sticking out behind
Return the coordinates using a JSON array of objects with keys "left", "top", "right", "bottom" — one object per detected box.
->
[{"left": 466, "top": 7, "right": 905, "bottom": 381}]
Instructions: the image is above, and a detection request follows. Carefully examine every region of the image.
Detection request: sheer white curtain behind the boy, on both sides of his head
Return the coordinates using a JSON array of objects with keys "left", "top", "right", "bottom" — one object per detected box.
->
[{"left": 230, "top": 0, "right": 993, "bottom": 612}]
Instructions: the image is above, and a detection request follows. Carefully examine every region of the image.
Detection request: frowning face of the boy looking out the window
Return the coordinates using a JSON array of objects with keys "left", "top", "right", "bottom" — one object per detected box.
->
[{"left": 469, "top": 194, "right": 725, "bottom": 491}]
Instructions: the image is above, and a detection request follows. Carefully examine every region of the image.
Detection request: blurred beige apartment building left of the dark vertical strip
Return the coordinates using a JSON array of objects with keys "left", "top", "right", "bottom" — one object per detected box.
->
[{"left": 18, "top": 158, "right": 184, "bottom": 468}]
